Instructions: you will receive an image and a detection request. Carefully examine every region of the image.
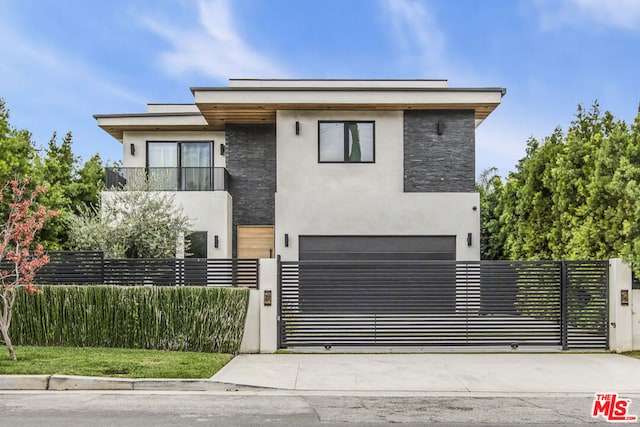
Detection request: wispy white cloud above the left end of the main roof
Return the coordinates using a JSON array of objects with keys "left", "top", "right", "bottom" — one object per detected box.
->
[{"left": 143, "top": 0, "right": 286, "bottom": 80}]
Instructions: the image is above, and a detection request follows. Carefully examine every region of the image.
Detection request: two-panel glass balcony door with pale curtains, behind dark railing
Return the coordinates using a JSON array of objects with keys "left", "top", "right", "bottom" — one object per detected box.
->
[{"left": 147, "top": 141, "right": 213, "bottom": 191}]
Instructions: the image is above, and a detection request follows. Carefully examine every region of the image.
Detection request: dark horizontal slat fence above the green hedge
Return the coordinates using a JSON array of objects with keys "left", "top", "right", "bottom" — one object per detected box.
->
[{"left": 0, "top": 251, "right": 259, "bottom": 289}]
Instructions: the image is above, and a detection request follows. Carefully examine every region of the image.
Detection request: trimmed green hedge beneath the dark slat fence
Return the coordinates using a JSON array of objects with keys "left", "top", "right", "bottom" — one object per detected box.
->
[{"left": 9, "top": 286, "right": 249, "bottom": 353}]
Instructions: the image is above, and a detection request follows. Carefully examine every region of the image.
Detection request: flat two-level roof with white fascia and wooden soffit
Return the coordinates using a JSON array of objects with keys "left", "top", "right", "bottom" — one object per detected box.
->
[{"left": 94, "top": 79, "right": 506, "bottom": 140}]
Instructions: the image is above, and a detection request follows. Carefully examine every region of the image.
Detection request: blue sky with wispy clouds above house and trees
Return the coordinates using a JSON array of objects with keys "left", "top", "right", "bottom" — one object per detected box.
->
[{"left": 0, "top": 0, "right": 640, "bottom": 175}]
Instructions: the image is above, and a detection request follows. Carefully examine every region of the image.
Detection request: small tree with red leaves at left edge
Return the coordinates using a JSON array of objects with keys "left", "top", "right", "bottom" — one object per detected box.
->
[{"left": 0, "top": 179, "right": 58, "bottom": 360}]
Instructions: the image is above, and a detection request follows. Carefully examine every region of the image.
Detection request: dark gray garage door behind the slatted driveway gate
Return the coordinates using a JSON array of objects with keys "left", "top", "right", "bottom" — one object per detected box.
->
[{"left": 299, "top": 236, "right": 456, "bottom": 313}]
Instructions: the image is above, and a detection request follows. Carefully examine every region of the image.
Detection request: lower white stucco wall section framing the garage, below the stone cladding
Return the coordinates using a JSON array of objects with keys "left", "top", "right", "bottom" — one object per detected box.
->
[{"left": 275, "top": 192, "right": 480, "bottom": 261}]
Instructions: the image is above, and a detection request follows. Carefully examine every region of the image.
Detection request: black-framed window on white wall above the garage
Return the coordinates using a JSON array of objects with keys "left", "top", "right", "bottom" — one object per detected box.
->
[{"left": 318, "top": 122, "right": 375, "bottom": 163}]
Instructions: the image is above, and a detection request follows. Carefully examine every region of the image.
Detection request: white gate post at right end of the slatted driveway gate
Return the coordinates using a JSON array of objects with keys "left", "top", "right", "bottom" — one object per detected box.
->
[{"left": 609, "top": 258, "right": 634, "bottom": 352}]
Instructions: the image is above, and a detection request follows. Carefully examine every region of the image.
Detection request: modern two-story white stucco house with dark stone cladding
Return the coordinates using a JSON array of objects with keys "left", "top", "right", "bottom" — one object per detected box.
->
[{"left": 95, "top": 79, "right": 505, "bottom": 261}]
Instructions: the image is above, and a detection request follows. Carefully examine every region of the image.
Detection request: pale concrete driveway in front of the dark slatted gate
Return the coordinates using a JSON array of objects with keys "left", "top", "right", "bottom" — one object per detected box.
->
[{"left": 211, "top": 353, "right": 640, "bottom": 396}]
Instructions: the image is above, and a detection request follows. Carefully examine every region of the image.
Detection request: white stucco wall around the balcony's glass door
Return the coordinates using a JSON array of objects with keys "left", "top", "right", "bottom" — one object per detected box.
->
[{"left": 122, "top": 131, "right": 227, "bottom": 168}]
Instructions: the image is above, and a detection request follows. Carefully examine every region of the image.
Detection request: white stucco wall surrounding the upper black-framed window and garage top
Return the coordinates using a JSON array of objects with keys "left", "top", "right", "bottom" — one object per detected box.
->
[{"left": 275, "top": 111, "right": 480, "bottom": 261}]
